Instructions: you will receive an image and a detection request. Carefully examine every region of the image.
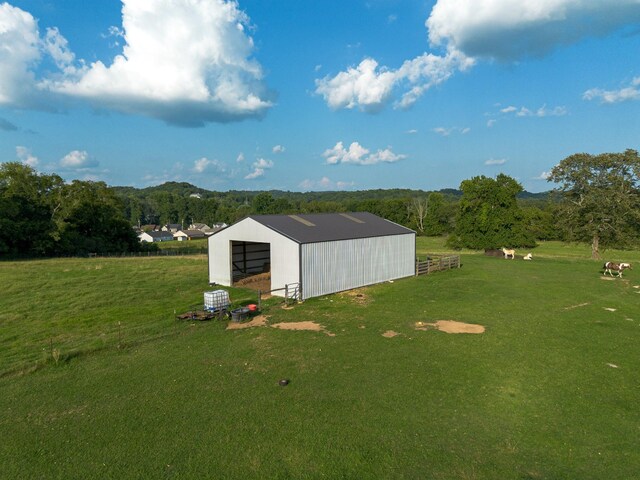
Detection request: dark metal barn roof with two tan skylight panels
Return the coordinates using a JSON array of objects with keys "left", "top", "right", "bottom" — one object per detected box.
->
[{"left": 249, "top": 212, "right": 415, "bottom": 243}]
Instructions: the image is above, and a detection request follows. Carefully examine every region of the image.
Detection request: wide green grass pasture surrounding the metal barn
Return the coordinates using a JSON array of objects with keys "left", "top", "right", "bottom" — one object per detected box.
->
[{"left": 0, "top": 239, "right": 640, "bottom": 479}]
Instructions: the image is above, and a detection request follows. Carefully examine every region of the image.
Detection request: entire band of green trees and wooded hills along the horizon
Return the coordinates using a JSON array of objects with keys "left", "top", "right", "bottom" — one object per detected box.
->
[{"left": 0, "top": 150, "right": 640, "bottom": 257}]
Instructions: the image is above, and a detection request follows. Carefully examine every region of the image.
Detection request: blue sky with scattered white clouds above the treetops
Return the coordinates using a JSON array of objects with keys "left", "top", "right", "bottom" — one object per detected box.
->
[{"left": 0, "top": 0, "right": 640, "bottom": 192}]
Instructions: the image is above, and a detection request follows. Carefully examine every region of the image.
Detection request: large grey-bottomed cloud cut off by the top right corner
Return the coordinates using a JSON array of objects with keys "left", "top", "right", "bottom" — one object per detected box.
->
[{"left": 426, "top": 0, "right": 640, "bottom": 61}]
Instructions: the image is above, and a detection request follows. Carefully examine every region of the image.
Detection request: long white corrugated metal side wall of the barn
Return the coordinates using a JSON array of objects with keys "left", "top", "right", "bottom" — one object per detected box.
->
[{"left": 302, "top": 233, "right": 416, "bottom": 299}]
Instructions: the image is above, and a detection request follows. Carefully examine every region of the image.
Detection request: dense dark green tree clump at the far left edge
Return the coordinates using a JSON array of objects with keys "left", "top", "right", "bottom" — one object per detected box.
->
[{"left": 0, "top": 162, "right": 143, "bottom": 256}]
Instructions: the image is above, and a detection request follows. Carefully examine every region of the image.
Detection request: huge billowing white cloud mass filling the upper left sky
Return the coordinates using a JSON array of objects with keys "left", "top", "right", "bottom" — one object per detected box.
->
[{"left": 0, "top": 0, "right": 272, "bottom": 126}]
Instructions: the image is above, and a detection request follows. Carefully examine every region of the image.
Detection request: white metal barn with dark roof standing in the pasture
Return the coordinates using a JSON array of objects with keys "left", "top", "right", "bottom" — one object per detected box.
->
[{"left": 209, "top": 212, "right": 416, "bottom": 299}]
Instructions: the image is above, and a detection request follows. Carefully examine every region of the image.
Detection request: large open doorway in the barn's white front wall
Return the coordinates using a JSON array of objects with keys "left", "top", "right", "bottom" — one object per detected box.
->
[{"left": 231, "top": 240, "right": 271, "bottom": 291}]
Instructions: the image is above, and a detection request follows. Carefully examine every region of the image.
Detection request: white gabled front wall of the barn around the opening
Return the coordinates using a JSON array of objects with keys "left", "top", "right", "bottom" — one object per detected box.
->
[{"left": 208, "top": 218, "right": 300, "bottom": 296}]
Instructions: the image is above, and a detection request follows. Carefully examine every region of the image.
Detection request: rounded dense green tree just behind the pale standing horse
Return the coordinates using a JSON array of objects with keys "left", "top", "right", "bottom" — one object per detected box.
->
[{"left": 449, "top": 173, "right": 535, "bottom": 249}]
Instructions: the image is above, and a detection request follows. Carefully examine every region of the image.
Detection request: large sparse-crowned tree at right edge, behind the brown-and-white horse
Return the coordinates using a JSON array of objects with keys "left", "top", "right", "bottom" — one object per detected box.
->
[{"left": 548, "top": 150, "right": 640, "bottom": 258}]
